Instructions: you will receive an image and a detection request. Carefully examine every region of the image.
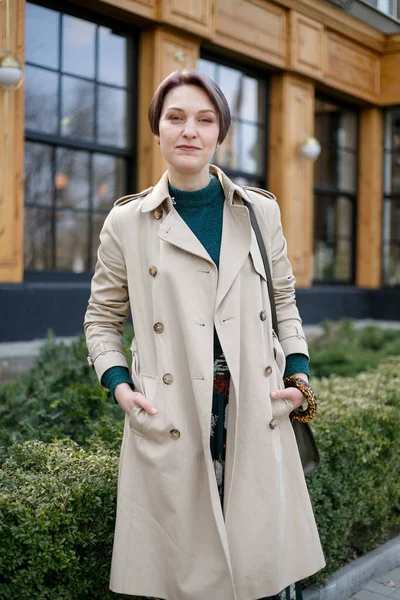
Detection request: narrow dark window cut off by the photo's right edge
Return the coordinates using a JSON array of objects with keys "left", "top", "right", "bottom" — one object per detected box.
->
[{"left": 382, "top": 108, "right": 400, "bottom": 285}]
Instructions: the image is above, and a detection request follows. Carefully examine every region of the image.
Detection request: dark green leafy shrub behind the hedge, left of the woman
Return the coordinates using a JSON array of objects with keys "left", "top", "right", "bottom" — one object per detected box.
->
[{"left": 0, "top": 336, "right": 123, "bottom": 458}]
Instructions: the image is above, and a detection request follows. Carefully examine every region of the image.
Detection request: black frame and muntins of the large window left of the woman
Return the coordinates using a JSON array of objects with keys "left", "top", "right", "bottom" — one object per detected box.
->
[{"left": 24, "top": 0, "right": 140, "bottom": 282}]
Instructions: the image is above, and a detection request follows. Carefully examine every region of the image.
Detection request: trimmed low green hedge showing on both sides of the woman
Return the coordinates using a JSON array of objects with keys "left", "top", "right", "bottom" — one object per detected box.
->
[{"left": 0, "top": 358, "right": 400, "bottom": 600}]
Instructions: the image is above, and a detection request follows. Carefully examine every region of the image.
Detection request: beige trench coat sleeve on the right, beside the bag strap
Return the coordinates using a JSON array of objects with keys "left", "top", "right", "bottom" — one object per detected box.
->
[{"left": 271, "top": 202, "right": 309, "bottom": 357}]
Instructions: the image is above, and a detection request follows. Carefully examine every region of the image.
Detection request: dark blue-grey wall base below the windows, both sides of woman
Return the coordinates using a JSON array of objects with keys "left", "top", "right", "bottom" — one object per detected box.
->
[{"left": 0, "top": 274, "right": 400, "bottom": 342}]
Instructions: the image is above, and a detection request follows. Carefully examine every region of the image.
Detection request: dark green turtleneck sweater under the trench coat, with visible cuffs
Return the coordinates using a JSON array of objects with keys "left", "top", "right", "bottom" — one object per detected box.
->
[{"left": 101, "top": 175, "right": 309, "bottom": 400}]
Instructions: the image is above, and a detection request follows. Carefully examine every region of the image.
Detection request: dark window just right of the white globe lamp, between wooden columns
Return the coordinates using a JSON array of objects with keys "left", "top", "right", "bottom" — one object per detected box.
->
[{"left": 313, "top": 98, "right": 358, "bottom": 283}]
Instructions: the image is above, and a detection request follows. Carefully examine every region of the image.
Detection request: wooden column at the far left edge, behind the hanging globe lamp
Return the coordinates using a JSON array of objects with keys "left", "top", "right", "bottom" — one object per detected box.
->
[{"left": 0, "top": 0, "right": 25, "bottom": 282}]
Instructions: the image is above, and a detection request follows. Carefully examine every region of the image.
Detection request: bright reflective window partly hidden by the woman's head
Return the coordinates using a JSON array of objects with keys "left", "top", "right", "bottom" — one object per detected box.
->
[{"left": 197, "top": 58, "right": 267, "bottom": 187}]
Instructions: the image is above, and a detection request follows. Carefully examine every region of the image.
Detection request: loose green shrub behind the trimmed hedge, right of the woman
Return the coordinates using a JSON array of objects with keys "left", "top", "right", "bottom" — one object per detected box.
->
[{"left": 310, "top": 319, "right": 400, "bottom": 377}]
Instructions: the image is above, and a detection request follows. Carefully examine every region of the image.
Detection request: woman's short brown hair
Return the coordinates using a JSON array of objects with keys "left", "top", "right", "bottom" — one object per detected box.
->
[{"left": 148, "top": 69, "right": 231, "bottom": 144}]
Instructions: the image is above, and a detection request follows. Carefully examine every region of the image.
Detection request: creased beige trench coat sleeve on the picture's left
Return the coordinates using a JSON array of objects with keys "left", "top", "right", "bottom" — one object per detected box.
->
[{"left": 84, "top": 209, "right": 129, "bottom": 382}]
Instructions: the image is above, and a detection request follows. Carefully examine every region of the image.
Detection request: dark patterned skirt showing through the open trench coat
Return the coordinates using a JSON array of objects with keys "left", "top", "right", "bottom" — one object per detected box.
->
[{"left": 129, "top": 350, "right": 303, "bottom": 600}]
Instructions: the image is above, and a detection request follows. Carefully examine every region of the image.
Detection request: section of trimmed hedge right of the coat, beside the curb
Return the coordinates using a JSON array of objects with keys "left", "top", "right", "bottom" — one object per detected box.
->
[{"left": 308, "top": 358, "right": 400, "bottom": 581}]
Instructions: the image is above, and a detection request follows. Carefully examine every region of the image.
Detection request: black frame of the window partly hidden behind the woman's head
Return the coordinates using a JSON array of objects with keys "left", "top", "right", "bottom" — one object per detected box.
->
[{"left": 199, "top": 53, "right": 271, "bottom": 189}]
